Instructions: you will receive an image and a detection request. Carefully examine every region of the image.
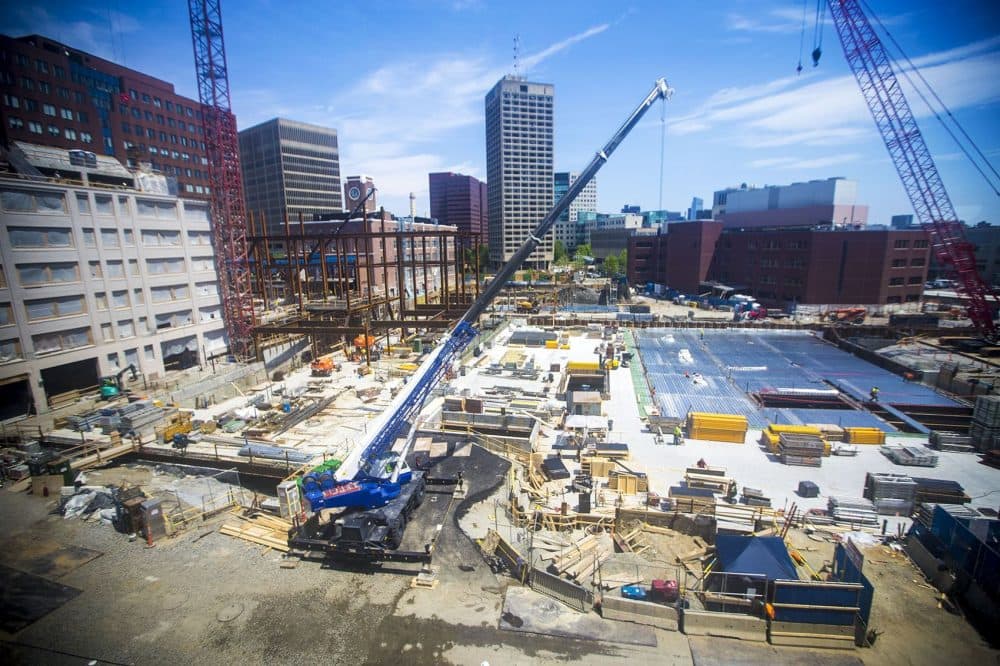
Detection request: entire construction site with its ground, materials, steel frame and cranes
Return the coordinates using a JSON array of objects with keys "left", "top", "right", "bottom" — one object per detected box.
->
[{"left": 0, "top": 0, "right": 1000, "bottom": 665}]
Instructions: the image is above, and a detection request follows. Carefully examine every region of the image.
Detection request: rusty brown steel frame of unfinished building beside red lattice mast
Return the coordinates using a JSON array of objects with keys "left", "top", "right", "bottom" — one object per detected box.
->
[{"left": 247, "top": 214, "right": 480, "bottom": 355}]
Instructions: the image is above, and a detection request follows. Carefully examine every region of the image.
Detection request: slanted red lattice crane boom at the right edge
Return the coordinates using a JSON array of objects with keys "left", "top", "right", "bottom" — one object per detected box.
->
[{"left": 814, "top": 0, "right": 997, "bottom": 340}]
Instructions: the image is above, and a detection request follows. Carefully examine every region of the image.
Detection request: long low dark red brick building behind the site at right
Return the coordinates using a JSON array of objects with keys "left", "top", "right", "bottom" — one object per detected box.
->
[{"left": 629, "top": 221, "right": 930, "bottom": 306}]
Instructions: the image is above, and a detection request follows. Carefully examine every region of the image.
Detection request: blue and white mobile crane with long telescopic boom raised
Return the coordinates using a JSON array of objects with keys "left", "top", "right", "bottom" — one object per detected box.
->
[{"left": 289, "top": 79, "right": 673, "bottom": 561}]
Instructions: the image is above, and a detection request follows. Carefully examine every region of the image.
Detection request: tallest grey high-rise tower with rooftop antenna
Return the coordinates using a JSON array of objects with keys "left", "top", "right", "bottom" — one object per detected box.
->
[{"left": 486, "top": 76, "right": 554, "bottom": 269}]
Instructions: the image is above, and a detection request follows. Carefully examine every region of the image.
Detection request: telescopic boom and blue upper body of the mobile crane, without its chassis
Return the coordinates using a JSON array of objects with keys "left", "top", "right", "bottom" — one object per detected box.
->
[{"left": 306, "top": 78, "right": 673, "bottom": 509}]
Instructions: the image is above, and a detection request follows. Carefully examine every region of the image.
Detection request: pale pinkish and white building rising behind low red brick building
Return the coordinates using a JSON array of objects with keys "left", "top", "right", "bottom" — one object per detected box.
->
[{"left": 712, "top": 178, "right": 868, "bottom": 229}]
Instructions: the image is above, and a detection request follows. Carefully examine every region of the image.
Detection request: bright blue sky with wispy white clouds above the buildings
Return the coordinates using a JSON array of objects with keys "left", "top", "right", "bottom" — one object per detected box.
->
[{"left": 0, "top": 0, "right": 1000, "bottom": 224}]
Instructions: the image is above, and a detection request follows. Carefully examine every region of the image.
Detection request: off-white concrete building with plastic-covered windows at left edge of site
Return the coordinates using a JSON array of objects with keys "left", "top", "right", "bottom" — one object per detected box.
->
[{"left": 0, "top": 158, "right": 227, "bottom": 418}]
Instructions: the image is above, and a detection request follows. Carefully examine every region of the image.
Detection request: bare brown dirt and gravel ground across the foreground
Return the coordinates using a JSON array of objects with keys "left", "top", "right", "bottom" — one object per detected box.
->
[{"left": 0, "top": 470, "right": 1000, "bottom": 665}]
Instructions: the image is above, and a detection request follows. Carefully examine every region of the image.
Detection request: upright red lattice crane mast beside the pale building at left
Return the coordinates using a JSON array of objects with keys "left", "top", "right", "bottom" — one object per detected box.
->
[{"left": 188, "top": 0, "right": 254, "bottom": 360}]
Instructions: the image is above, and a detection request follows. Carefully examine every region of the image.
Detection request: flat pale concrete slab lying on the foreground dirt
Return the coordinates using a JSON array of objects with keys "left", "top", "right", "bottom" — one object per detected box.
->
[{"left": 500, "top": 587, "right": 656, "bottom": 646}]
